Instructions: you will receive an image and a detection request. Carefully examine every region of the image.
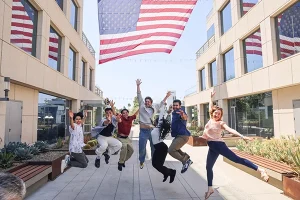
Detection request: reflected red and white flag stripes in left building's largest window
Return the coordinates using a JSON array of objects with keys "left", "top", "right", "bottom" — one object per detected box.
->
[{"left": 10, "top": 0, "right": 34, "bottom": 54}]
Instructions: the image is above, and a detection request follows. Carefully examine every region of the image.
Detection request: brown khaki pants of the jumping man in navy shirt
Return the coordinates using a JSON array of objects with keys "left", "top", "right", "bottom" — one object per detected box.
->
[{"left": 168, "top": 135, "right": 190, "bottom": 164}]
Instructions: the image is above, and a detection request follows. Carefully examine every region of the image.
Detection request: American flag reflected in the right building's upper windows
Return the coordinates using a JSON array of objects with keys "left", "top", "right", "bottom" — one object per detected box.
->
[{"left": 243, "top": 0, "right": 300, "bottom": 58}]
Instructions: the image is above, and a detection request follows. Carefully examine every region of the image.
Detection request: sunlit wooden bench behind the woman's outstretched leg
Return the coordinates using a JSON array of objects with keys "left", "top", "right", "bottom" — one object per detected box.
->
[{"left": 224, "top": 149, "right": 293, "bottom": 190}]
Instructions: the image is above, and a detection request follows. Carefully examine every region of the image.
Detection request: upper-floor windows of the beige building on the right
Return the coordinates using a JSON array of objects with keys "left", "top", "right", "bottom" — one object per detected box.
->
[{"left": 199, "top": 0, "right": 300, "bottom": 90}]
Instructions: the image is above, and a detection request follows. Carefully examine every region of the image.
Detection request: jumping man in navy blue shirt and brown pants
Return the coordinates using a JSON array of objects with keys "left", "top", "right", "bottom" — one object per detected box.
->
[{"left": 168, "top": 100, "right": 193, "bottom": 173}]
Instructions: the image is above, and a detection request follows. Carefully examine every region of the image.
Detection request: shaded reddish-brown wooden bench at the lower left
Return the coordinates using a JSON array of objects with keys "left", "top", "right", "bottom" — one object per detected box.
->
[{"left": 12, "top": 165, "right": 52, "bottom": 197}]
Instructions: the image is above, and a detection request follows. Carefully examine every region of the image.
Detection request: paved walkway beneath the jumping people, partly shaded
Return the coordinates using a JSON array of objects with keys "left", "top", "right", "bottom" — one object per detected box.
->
[{"left": 26, "top": 127, "right": 289, "bottom": 200}]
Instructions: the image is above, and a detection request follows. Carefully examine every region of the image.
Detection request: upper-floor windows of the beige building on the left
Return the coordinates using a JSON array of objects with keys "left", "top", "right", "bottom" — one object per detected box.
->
[{"left": 10, "top": 0, "right": 93, "bottom": 90}]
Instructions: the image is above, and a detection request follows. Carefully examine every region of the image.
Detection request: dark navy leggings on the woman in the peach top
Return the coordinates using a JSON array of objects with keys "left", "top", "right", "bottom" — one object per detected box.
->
[{"left": 206, "top": 141, "right": 258, "bottom": 186}]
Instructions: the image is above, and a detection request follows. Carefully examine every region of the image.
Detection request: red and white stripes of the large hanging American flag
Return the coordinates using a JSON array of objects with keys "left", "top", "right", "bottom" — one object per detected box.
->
[{"left": 99, "top": 0, "right": 197, "bottom": 64}]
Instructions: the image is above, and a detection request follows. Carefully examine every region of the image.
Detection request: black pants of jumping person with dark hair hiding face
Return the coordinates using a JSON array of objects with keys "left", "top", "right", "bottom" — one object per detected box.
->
[{"left": 152, "top": 142, "right": 172, "bottom": 176}]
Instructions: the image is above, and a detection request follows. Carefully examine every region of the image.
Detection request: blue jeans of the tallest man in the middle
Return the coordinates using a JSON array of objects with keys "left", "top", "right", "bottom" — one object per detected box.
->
[{"left": 139, "top": 128, "right": 154, "bottom": 163}]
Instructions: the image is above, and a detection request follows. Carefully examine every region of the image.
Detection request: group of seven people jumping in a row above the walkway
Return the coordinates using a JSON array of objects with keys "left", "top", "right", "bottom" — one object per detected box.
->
[{"left": 61, "top": 79, "right": 269, "bottom": 199}]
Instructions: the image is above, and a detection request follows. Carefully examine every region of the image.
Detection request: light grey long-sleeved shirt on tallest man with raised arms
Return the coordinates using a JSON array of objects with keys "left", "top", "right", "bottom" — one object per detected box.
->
[{"left": 137, "top": 92, "right": 164, "bottom": 126}]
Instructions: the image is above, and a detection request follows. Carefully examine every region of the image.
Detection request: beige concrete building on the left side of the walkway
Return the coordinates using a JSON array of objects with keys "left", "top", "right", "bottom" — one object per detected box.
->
[{"left": 0, "top": 0, "right": 103, "bottom": 147}]
